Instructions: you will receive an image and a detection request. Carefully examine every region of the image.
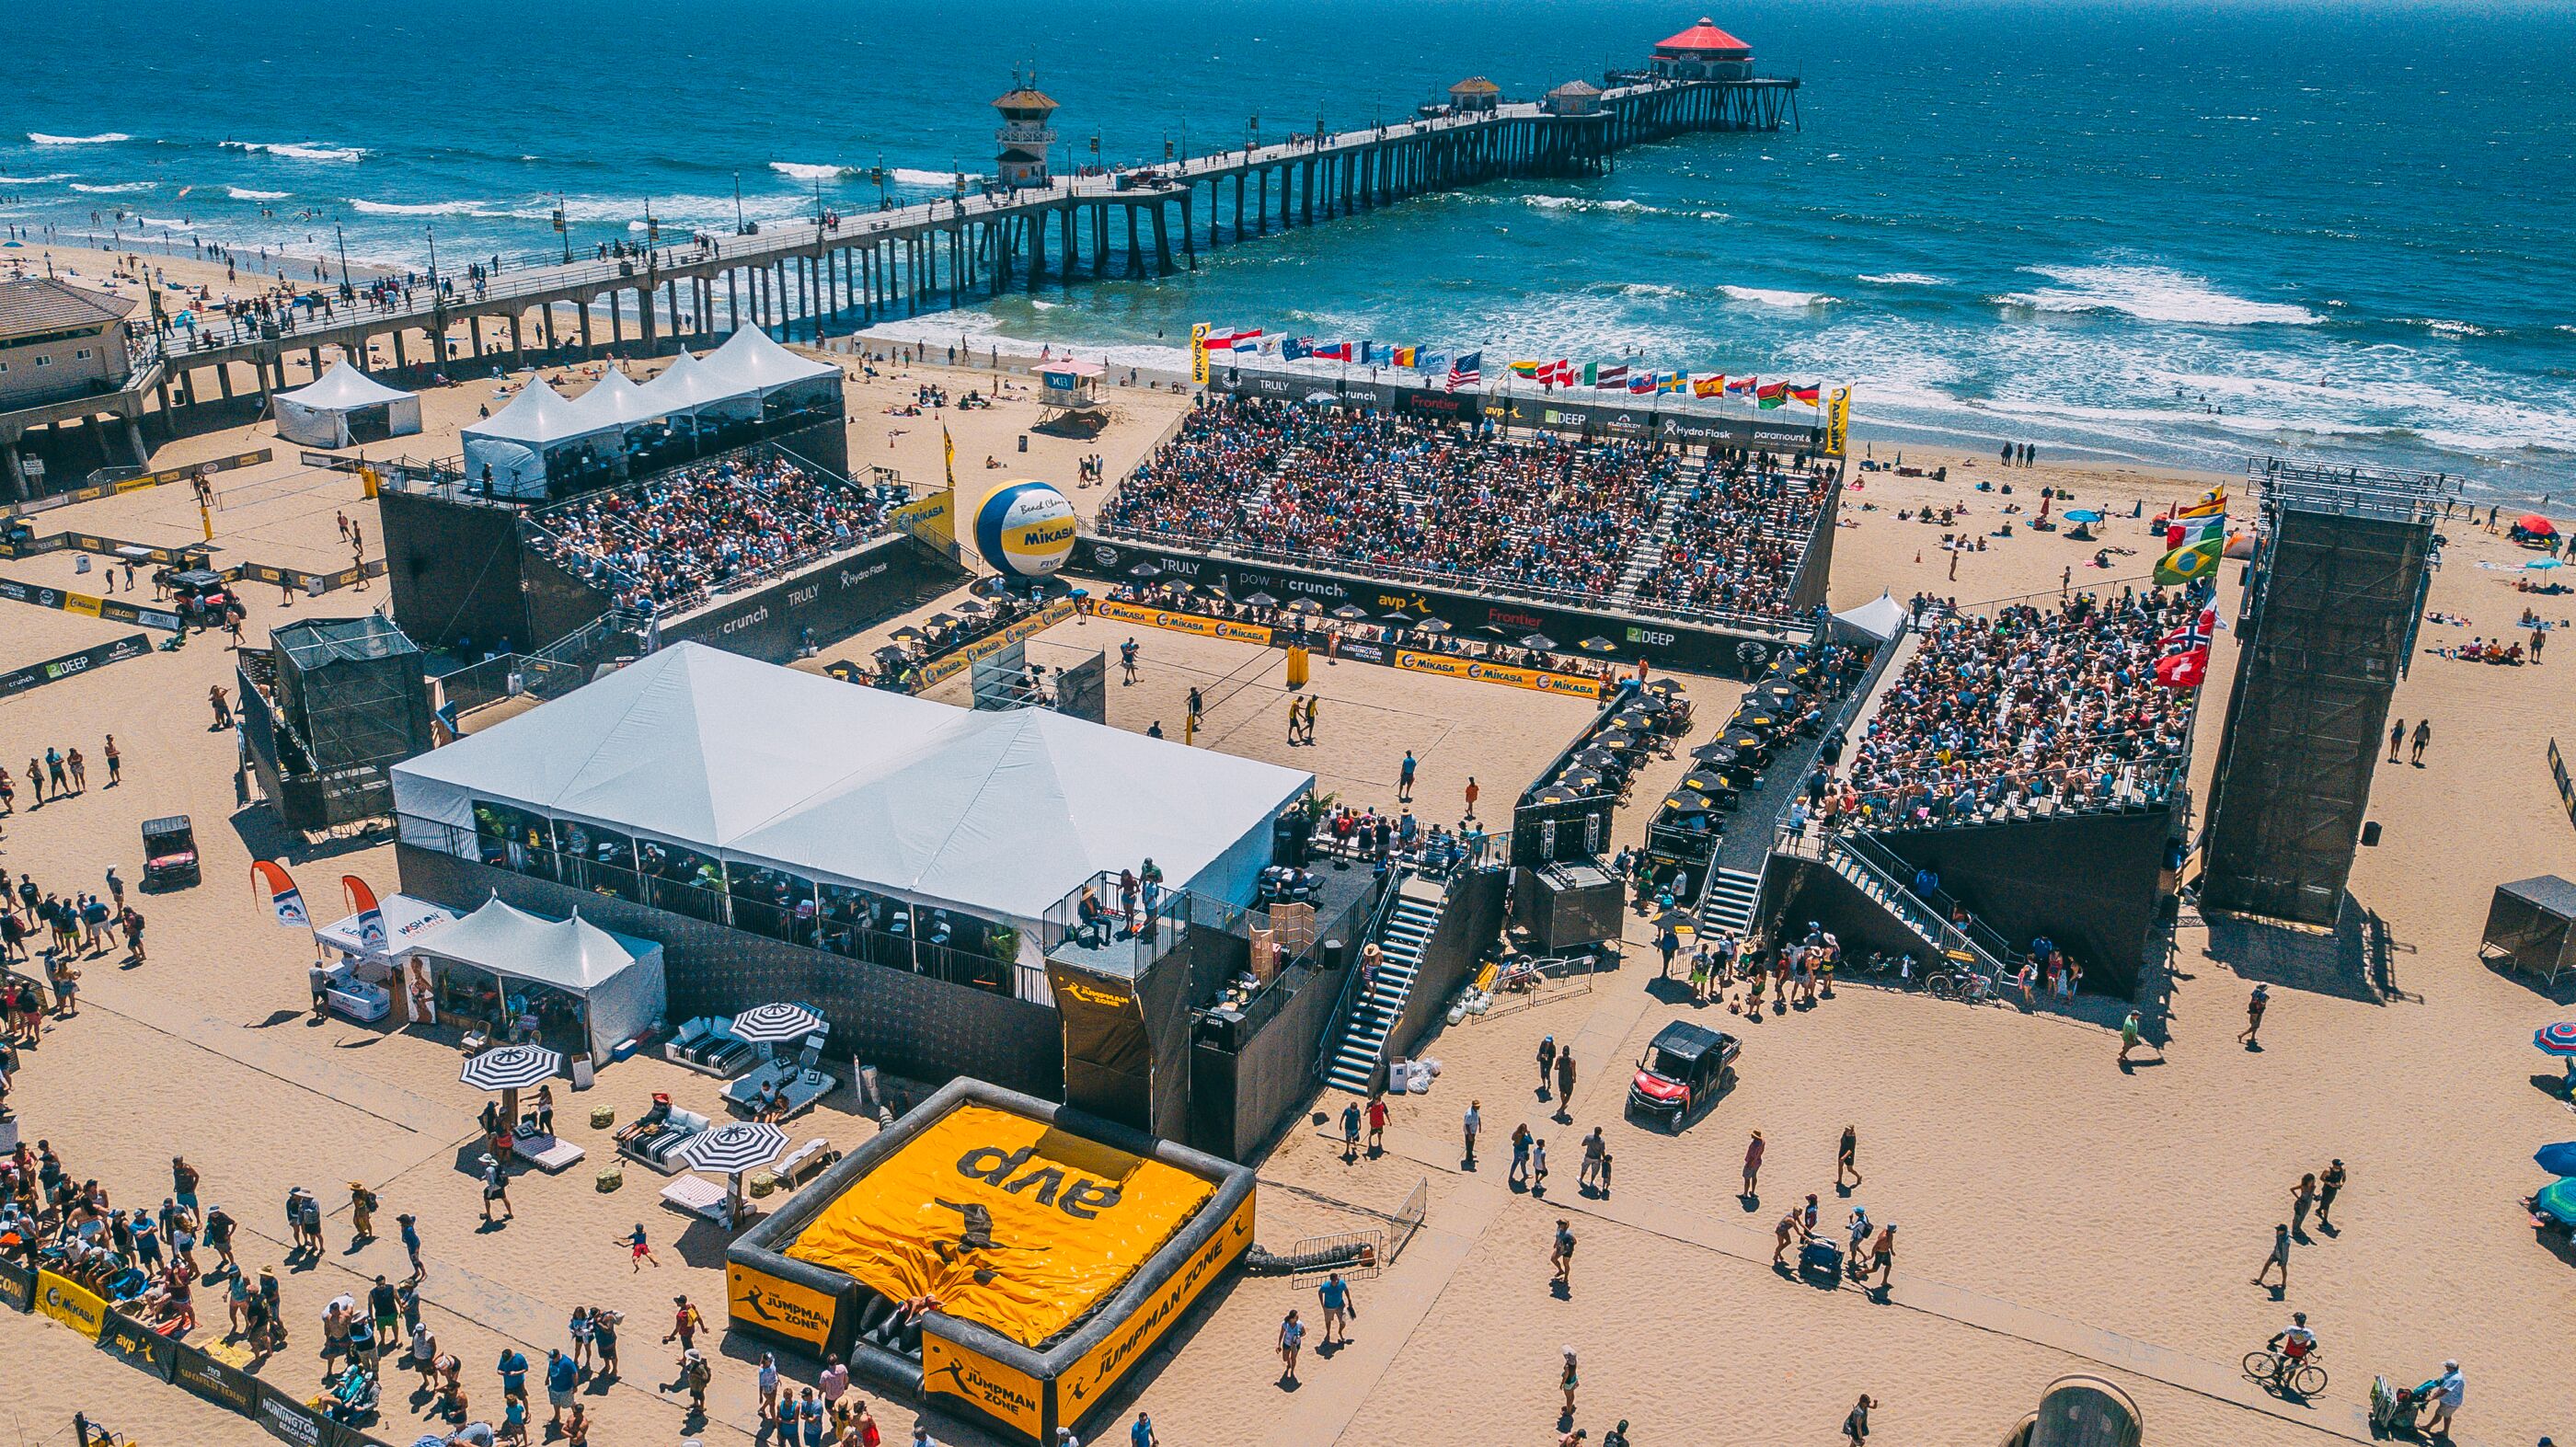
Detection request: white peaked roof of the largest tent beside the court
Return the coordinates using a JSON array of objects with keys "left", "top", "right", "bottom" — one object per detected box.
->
[{"left": 394, "top": 644, "right": 1314, "bottom": 999}]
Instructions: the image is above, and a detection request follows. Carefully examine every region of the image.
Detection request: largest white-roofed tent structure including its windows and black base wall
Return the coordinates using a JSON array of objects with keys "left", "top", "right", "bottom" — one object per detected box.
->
[{"left": 394, "top": 644, "right": 1314, "bottom": 1097}]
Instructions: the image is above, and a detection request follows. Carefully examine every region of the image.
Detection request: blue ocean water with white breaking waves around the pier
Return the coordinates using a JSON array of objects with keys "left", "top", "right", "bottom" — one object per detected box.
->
[{"left": 0, "top": 0, "right": 2576, "bottom": 497}]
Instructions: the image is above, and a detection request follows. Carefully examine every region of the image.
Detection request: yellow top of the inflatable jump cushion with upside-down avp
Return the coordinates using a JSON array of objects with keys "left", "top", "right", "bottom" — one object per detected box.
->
[{"left": 786, "top": 1105, "right": 1216, "bottom": 1347}]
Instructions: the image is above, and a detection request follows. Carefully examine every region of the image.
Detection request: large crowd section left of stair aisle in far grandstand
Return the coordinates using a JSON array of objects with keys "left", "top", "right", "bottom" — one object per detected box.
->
[{"left": 1100, "top": 396, "right": 1700, "bottom": 603}]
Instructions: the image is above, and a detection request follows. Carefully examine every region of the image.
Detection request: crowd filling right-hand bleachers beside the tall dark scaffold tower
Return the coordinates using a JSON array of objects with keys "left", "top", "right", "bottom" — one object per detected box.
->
[{"left": 1822, "top": 590, "right": 2197, "bottom": 829}]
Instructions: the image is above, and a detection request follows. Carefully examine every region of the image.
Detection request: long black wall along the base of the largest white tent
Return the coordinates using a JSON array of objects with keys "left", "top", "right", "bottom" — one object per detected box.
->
[{"left": 394, "top": 844, "right": 1064, "bottom": 1099}]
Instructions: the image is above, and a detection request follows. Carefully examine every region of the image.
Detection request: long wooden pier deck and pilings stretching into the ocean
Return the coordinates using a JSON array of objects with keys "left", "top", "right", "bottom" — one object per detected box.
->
[{"left": 131, "top": 72, "right": 1798, "bottom": 415}]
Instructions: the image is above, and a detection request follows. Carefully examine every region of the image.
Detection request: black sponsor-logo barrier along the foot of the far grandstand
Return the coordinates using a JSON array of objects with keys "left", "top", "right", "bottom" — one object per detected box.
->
[{"left": 1064, "top": 533, "right": 1788, "bottom": 677}]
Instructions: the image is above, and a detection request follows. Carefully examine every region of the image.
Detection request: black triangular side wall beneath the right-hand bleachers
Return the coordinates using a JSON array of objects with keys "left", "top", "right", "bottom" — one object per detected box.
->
[{"left": 1878, "top": 806, "right": 2174, "bottom": 993}]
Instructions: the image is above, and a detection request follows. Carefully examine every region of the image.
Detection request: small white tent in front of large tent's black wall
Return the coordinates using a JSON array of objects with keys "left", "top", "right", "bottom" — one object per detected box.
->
[{"left": 402, "top": 899, "right": 664, "bottom": 1066}]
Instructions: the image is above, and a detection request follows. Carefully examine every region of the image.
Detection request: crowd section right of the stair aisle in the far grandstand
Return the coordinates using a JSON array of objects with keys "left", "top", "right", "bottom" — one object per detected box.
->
[{"left": 1636, "top": 458, "right": 1834, "bottom": 618}]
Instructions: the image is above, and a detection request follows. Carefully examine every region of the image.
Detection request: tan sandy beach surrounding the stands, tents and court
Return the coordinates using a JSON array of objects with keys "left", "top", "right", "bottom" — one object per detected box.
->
[{"left": 0, "top": 337, "right": 2576, "bottom": 1447}]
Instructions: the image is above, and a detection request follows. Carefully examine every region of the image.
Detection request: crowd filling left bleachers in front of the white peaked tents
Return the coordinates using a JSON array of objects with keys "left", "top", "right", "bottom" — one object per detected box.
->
[{"left": 535, "top": 455, "right": 886, "bottom": 613}]
